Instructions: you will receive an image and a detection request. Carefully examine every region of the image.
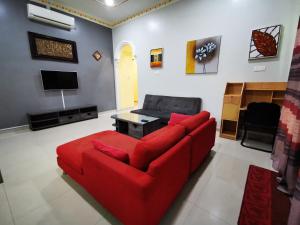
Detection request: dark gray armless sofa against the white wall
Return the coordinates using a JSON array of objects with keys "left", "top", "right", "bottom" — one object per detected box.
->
[{"left": 131, "top": 94, "right": 201, "bottom": 123}]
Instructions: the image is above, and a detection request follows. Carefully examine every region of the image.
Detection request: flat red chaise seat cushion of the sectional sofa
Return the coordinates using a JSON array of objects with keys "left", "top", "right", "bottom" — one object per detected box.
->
[{"left": 56, "top": 131, "right": 138, "bottom": 174}]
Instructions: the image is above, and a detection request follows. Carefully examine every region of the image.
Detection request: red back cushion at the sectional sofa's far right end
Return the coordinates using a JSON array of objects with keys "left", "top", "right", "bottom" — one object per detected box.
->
[{"left": 179, "top": 111, "right": 210, "bottom": 134}]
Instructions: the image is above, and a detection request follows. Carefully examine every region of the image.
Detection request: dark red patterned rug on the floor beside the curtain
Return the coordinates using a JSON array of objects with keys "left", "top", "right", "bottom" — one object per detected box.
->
[{"left": 238, "top": 165, "right": 290, "bottom": 225}]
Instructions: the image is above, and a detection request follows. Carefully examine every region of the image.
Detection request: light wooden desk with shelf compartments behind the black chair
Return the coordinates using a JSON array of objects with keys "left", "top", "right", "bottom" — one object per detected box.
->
[{"left": 220, "top": 82, "right": 287, "bottom": 140}]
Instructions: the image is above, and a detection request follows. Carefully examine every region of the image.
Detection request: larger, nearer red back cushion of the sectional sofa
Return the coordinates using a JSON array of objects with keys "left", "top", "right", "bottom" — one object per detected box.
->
[{"left": 130, "top": 125, "right": 185, "bottom": 170}]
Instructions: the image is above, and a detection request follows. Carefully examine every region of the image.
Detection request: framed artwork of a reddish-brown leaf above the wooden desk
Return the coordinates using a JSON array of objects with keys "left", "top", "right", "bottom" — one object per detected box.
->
[{"left": 249, "top": 25, "right": 282, "bottom": 60}]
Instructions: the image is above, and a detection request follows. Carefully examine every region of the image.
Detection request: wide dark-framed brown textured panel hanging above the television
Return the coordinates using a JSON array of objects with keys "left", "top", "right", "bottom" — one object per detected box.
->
[{"left": 28, "top": 31, "right": 78, "bottom": 63}]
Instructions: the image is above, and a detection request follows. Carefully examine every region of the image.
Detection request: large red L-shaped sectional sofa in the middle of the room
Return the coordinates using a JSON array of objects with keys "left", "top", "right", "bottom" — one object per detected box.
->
[{"left": 57, "top": 111, "right": 216, "bottom": 225}]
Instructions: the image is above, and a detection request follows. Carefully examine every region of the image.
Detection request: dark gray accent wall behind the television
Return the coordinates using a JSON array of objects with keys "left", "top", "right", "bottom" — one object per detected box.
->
[{"left": 0, "top": 0, "right": 116, "bottom": 129}]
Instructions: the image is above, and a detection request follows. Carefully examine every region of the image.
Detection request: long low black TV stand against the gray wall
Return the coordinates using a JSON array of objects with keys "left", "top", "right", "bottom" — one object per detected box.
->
[{"left": 27, "top": 106, "right": 98, "bottom": 131}]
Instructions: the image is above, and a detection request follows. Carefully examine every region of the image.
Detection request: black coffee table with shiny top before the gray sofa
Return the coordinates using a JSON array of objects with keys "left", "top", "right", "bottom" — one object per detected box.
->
[{"left": 111, "top": 113, "right": 165, "bottom": 138}]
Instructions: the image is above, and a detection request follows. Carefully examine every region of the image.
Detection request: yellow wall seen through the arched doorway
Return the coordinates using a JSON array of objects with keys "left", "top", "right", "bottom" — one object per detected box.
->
[{"left": 118, "top": 45, "right": 138, "bottom": 109}]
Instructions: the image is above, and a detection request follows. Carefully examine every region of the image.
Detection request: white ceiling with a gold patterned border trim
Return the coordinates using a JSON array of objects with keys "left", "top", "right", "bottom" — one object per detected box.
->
[{"left": 33, "top": 0, "right": 178, "bottom": 27}]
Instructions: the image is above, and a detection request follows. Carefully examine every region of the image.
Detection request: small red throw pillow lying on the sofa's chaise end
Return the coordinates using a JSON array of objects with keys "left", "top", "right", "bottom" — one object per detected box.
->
[{"left": 92, "top": 140, "right": 129, "bottom": 163}]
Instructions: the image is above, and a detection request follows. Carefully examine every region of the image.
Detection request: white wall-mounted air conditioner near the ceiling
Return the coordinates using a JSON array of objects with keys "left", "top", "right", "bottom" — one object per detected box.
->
[{"left": 27, "top": 4, "right": 75, "bottom": 30}]
